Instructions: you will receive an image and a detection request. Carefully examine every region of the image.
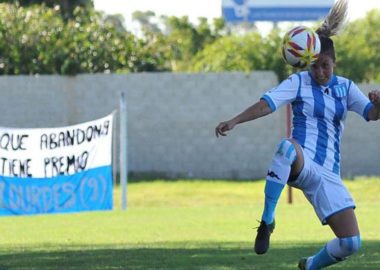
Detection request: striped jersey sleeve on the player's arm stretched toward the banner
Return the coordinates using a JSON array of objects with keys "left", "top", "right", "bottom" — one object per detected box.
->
[{"left": 261, "top": 74, "right": 301, "bottom": 112}]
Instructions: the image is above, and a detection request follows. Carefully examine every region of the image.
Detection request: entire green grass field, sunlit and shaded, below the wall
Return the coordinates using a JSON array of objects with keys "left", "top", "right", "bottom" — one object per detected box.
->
[{"left": 0, "top": 178, "right": 380, "bottom": 270}]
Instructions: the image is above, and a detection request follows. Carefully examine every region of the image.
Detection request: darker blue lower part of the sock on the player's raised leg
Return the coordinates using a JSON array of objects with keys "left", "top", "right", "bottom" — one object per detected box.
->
[{"left": 261, "top": 181, "right": 284, "bottom": 224}]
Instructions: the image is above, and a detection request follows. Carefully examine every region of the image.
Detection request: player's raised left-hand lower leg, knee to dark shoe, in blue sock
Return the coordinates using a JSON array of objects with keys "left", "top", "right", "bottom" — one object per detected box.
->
[{"left": 254, "top": 139, "right": 297, "bottom": 254}]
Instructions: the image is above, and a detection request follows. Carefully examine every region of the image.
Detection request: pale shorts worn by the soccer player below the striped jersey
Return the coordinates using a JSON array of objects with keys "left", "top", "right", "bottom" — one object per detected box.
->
[{"left": 288, "top": 147, "right": 355, "bottom": 225}]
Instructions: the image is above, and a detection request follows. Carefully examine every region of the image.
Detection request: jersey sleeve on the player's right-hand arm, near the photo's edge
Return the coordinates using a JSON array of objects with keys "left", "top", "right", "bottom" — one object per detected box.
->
[{"left": 347, "top": 82, "right": 373, "bottom": 121}]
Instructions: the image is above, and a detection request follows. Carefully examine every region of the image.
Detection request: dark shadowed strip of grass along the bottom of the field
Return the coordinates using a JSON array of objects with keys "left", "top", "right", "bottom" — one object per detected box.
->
[{"left": 0, "top": 241, "right": 380, "bottom": 270}]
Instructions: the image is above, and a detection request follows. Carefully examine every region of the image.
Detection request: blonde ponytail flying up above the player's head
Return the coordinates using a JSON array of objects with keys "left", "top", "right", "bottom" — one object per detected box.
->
[{"left": 315, "top": 0, "right": 348, "bottom": 37}]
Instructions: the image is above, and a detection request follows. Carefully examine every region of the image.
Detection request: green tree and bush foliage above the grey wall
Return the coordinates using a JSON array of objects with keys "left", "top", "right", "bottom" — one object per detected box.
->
[{"left": 0, "top": 0, "right": 380, "bottom": 82}]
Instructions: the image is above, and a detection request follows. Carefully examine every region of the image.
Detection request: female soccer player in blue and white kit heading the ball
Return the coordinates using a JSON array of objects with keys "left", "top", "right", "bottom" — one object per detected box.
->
[{"left": 215, "top": 0, "right": 380, "bottom": 270}]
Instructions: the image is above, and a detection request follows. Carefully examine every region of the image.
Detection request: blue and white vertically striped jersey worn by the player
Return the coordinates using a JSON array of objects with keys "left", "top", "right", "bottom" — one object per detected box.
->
[{"left": 262, "top": 71, "right": 373, "bottom": 175}]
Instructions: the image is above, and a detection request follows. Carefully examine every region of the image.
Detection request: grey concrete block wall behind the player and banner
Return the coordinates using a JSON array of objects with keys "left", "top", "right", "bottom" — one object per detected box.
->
[{"left": 0, "top": 72, "right": 380, "bottom": 178}]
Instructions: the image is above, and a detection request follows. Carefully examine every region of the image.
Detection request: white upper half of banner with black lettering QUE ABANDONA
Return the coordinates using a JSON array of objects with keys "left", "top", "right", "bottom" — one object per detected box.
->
[{"left": 0, "top": 114, "right": 113, "bottom": 178}]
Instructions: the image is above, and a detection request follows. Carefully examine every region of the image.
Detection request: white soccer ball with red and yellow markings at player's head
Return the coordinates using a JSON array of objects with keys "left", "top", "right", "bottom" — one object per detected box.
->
[{"left": 282, "top": 26, "right": 321, "bottom": 68}]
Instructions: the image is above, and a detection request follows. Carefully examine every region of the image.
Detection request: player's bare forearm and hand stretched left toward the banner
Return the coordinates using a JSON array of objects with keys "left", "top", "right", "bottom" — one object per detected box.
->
[{"left": 215, "top": 100, "right": 272, "bottom": 137}]
